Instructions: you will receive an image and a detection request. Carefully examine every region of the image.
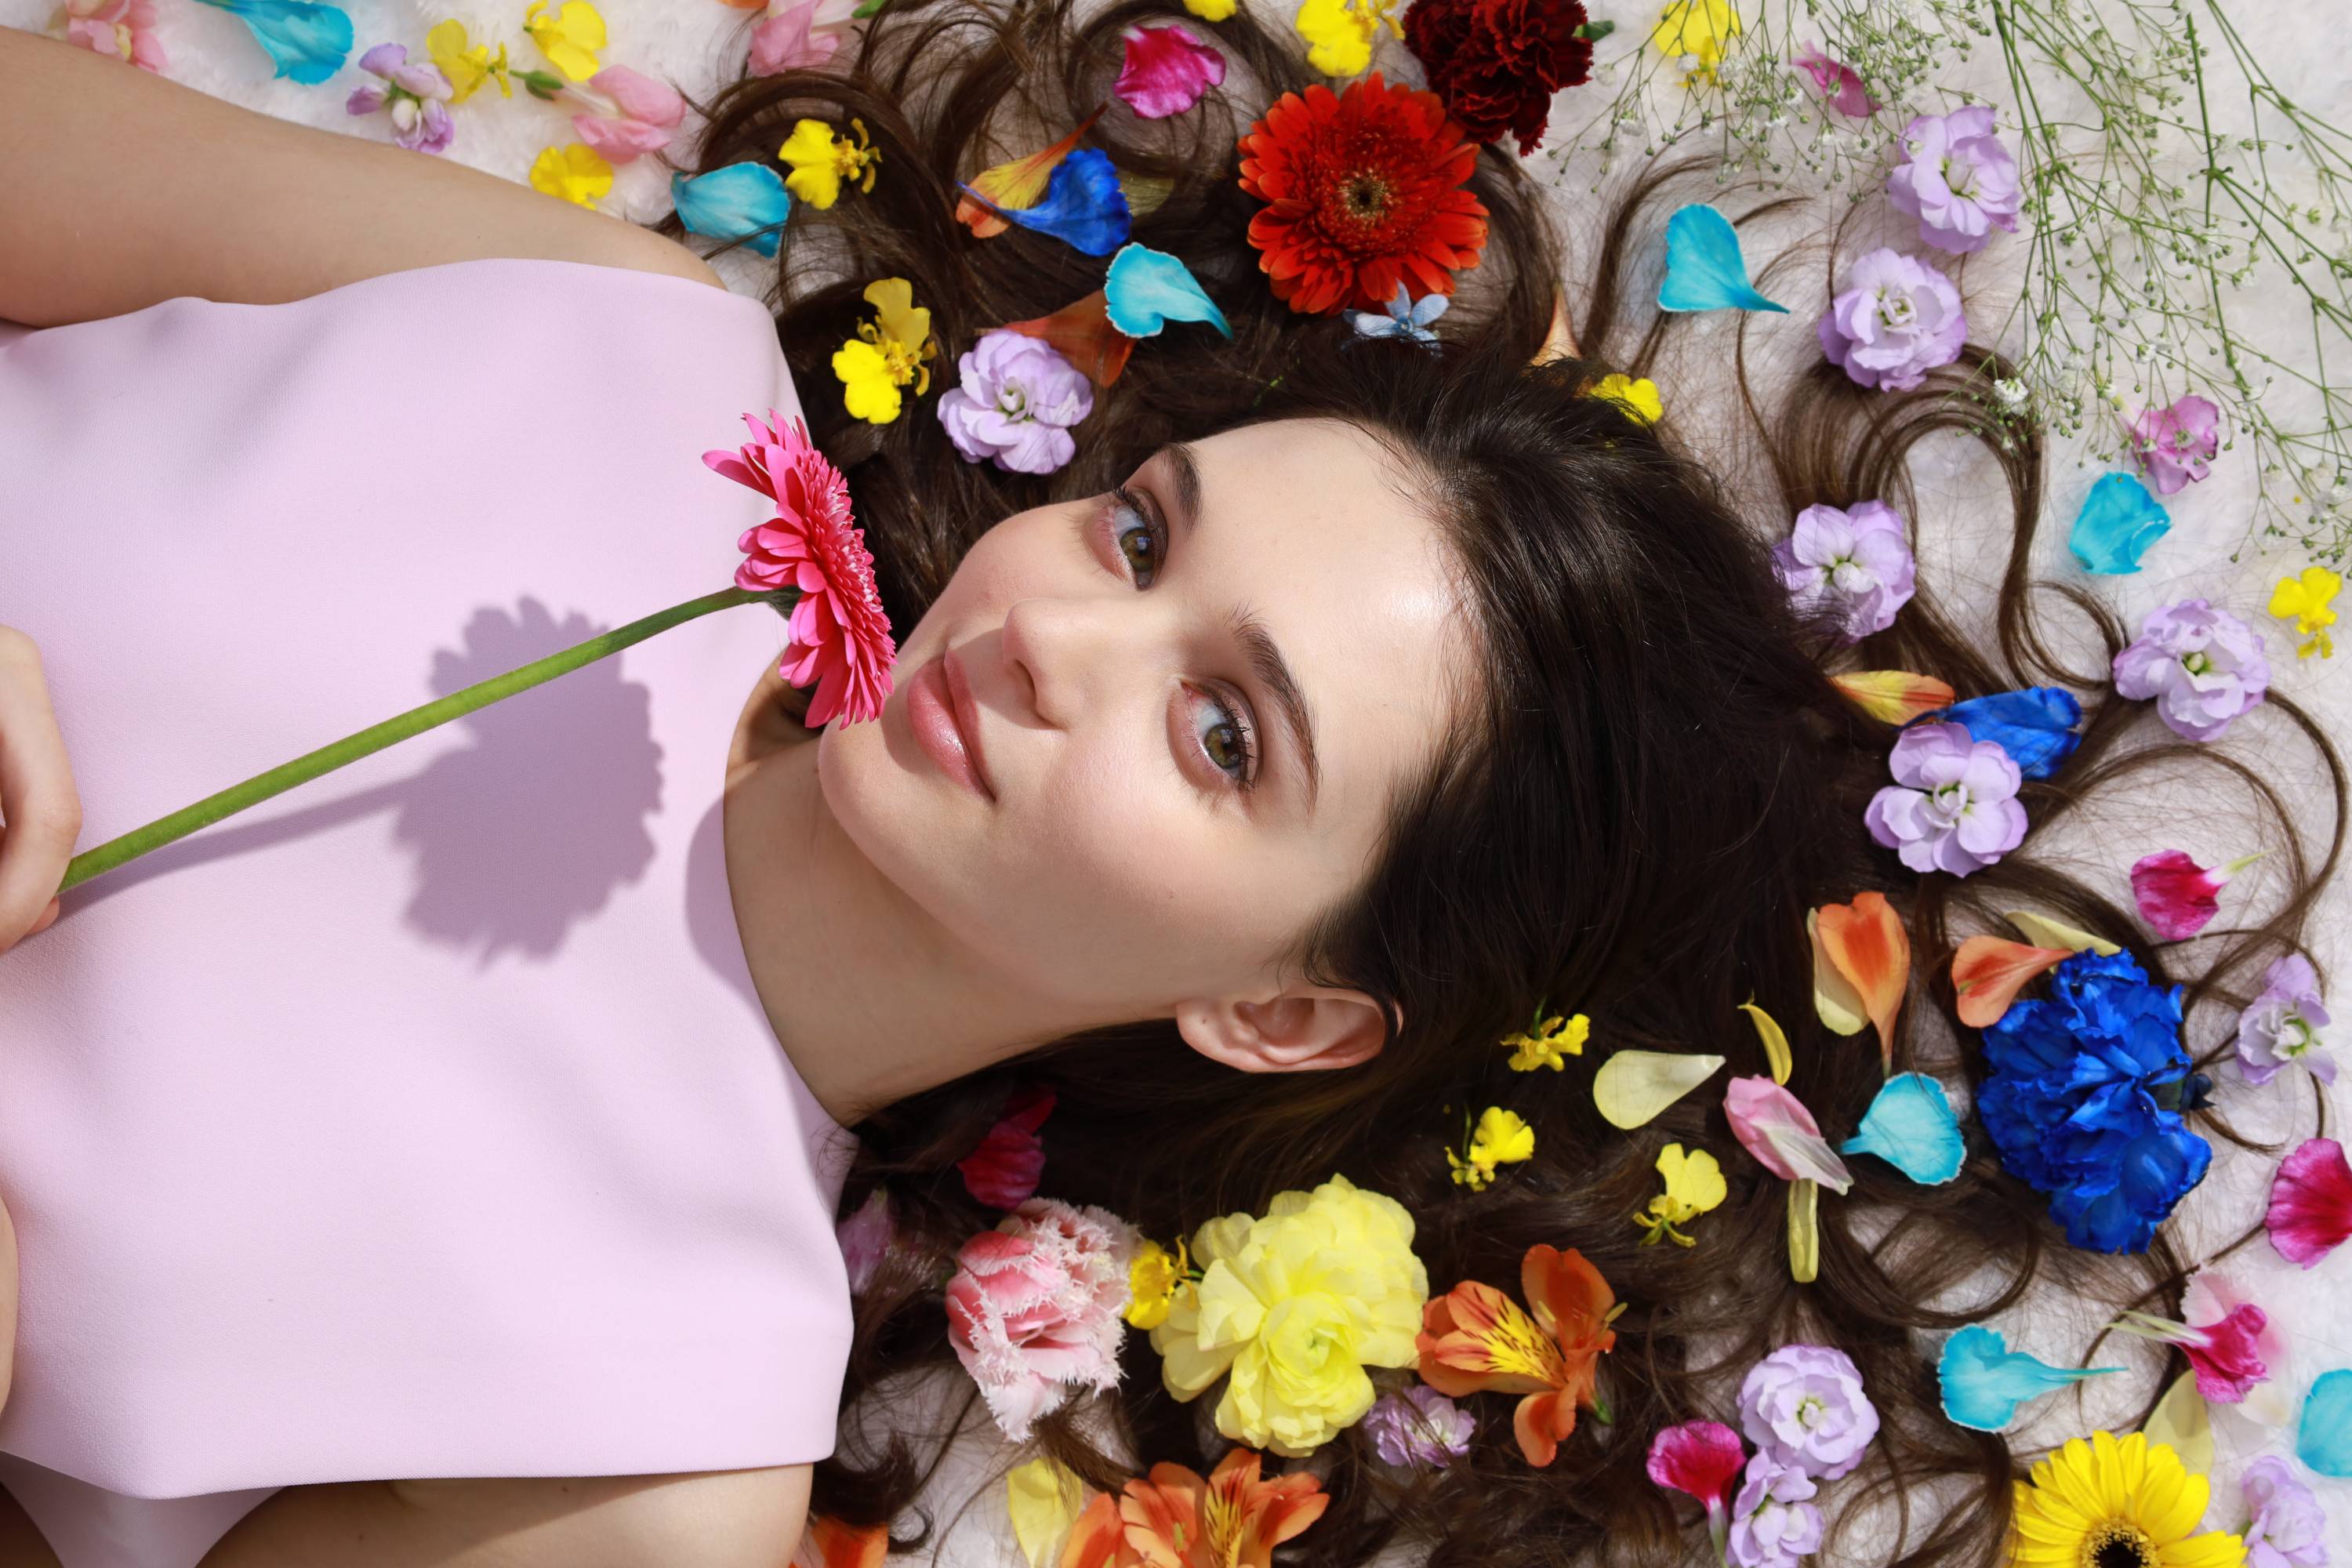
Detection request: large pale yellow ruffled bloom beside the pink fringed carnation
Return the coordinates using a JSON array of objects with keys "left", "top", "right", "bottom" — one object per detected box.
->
[{"left": 1152, "top": 1175, "right": 1430, "bottom": 1457}]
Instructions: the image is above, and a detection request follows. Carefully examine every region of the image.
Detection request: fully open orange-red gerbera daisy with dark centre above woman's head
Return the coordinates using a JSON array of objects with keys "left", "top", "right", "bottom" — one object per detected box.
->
[{"left": 1242, "top": 71, "right": 1486, "bottom": 315}]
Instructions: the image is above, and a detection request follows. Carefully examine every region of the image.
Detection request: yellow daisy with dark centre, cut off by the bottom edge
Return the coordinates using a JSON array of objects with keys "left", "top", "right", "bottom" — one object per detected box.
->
[{"left": 2009, "top": 1432, "right": 2246, "bottom": 1568}]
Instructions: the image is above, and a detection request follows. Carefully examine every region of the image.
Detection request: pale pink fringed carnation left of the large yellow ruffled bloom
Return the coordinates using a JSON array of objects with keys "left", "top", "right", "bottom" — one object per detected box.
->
[{"left": 948, "top": 1199, "right": 1136, "bottom": 1443}]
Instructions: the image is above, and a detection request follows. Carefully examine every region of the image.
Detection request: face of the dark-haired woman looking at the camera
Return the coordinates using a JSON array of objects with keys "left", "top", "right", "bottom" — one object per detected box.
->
[{"left": 818, "top": 421, "right": 1470, "bottom": 1044}]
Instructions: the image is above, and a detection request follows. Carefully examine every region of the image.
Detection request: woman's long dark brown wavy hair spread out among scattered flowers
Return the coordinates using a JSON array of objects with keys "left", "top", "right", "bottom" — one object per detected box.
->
[{"left": 644, "top": 0, "right": 2345, "bottom": 1568}]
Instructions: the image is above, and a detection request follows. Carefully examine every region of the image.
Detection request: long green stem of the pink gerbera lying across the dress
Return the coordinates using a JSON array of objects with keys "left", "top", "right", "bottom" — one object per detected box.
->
[{"left": 59, "top": 588, "right": 800, "bottom": 891}]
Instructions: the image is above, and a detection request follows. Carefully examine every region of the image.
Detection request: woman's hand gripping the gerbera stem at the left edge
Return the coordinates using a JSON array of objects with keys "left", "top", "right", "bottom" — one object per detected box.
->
[{"left": 0, "top": 626, "right": 82, "bottom": 952}]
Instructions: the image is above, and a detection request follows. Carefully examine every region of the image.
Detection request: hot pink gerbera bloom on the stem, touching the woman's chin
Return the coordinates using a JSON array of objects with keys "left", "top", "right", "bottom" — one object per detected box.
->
[{"left": 703, "top": 409, "right": 898, "bottom": 729}]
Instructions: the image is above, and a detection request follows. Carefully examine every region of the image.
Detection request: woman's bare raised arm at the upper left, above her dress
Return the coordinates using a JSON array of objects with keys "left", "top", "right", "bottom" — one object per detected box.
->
[{"left": 0, "top": 28, "right": 722, "bottom": 327}]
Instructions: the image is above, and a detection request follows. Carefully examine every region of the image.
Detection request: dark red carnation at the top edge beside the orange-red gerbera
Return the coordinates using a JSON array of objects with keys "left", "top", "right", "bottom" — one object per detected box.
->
[{"left": 1404, "top": 0, "right": 1592, "bottom": 158}]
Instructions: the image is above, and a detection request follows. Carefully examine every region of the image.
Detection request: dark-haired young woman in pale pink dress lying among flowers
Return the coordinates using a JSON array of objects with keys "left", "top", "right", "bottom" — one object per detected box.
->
[{"left": 0, "top": 0, "right": 2326, "bottom": 1568}]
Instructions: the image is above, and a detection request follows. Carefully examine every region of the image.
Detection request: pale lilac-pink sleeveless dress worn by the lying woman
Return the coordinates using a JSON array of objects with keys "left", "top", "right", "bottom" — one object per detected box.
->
[{"left": 0, "top": 261, "right": 849, "bottom": 1568}]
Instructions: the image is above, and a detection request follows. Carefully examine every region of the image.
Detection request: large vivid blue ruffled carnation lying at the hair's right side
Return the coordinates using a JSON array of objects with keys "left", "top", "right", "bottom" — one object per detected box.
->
[{"left": 1976, "top": 952, "right": 2213, "bottom": 1253}]
